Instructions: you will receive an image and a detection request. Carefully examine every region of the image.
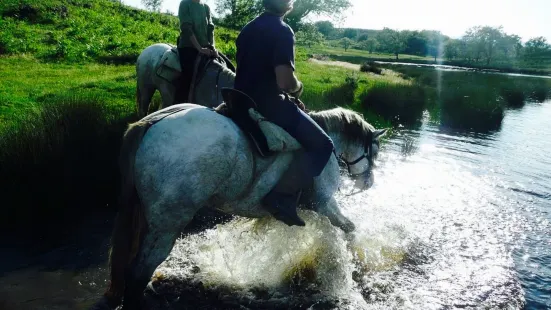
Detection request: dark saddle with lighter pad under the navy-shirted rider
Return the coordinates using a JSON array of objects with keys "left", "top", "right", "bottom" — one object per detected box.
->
[{"left": 215, "top": 88, "right": 302, "bottom": 157}]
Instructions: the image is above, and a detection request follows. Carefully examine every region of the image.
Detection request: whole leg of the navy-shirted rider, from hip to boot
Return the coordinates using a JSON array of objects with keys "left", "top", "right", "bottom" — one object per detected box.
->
[{"left": 263, "top": 101, "right": 333, "bottom": 226}]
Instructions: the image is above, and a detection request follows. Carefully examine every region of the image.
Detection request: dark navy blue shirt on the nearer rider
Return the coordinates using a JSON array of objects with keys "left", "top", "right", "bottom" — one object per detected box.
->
[{"left": 234, "top": 13, "right": 295, "bottom": 111}]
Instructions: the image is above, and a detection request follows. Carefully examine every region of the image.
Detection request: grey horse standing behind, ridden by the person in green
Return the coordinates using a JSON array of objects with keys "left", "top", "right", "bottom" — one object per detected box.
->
[{"left": 136, "top": 43, "right": 235, "bottom": 117}]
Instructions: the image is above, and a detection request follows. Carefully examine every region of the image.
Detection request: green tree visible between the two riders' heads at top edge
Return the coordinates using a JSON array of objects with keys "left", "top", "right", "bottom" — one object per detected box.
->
[{"left": 216, "top": 0, "right": 262, "bottom": 30}]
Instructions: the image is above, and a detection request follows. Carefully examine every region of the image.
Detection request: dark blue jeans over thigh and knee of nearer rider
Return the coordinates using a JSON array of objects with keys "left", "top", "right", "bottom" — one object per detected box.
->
[{"left": 259, "top": 98, "right": 334, "bottom": 178}]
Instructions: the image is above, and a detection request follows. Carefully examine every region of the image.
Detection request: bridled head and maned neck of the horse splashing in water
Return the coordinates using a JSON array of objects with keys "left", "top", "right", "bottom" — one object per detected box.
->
[{"left": 311, "top": 108, "right": 388, "bottom": 190}]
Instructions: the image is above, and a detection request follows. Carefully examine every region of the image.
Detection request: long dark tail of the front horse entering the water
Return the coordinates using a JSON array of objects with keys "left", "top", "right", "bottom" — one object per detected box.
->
[{"left": 105, "top": 121, "right": 151, "bottom": 305}]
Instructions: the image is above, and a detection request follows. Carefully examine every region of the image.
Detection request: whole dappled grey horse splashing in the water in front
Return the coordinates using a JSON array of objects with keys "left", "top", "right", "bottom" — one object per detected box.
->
[{"left": 94, "top": 104, "right": 386, "bottom": 309}]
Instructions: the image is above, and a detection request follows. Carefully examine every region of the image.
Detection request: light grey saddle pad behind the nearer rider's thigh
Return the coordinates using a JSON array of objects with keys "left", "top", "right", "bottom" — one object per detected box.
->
[{"left": 249, "top": 108, "right": 302, "bottom": 152}]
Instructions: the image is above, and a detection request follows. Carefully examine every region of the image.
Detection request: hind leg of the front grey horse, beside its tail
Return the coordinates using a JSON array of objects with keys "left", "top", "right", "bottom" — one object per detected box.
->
[{"left": 123, "top": 205, "right": 201, "bottom": 310}]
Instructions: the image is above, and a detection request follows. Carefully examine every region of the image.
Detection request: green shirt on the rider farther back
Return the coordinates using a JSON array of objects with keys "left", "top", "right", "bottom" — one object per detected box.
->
[{"left": 178, "top": 0, "right": 214, "bottom": 48}]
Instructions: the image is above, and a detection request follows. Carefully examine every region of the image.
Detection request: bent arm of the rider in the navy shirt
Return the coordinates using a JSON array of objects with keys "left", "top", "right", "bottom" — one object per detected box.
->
[{"left": 272, "top": 28, "right": 302, "bottom": 94}]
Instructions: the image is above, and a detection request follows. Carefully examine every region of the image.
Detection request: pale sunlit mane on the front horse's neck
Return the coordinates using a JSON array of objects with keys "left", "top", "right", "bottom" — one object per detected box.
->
[{"left": 309, "top": 108, "right": 375, "bottom": 144}]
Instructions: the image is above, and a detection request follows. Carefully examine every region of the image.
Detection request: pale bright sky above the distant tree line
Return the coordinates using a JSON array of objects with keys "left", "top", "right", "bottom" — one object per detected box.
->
[{"left": 123, "top": 0, "right": 551, "bottom": 42}]
